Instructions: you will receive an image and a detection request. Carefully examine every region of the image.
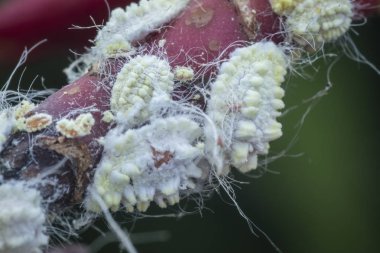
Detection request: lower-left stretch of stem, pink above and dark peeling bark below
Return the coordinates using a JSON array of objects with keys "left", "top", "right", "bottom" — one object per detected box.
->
[{"left": 0, "top": 73, "right": 114, "bottom": 212}]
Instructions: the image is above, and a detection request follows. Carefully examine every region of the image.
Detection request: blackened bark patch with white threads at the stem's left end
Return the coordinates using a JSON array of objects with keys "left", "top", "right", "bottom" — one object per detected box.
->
[{"left": 0, "top": 132, "right": 76, "bottom": 213}]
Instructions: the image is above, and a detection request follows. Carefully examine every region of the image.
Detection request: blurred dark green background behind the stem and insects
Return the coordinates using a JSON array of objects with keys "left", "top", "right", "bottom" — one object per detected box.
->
[{"left": 0, "top": 1, "right": 380, "bottom": 253}]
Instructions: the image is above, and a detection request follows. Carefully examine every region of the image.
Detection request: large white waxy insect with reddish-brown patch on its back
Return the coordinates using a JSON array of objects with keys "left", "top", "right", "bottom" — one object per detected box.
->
[{"left": 87, "top": 116, "right": 203, "bottom": 212}]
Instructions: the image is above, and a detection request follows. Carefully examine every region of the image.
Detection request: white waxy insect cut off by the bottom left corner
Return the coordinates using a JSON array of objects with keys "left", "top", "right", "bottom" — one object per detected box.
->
[{"left": 0, "top": 181, "right": 48, "bottom": 253}]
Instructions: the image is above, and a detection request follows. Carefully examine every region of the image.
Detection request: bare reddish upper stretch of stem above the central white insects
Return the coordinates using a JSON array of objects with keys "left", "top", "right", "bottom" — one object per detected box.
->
[{"left": 148, "top": 0, "right": 281, "bottom": 71}]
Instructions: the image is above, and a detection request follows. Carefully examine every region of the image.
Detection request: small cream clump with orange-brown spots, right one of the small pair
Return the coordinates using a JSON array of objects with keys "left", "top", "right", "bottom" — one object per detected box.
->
[{"left": 56, "top": 113, "right": 95, "bottom": 138}]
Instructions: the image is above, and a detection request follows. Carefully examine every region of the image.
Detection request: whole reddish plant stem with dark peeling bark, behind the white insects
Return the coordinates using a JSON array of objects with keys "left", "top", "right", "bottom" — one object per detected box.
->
[{"left": 0, "top": 0, "right": 378, "bottom": 209}]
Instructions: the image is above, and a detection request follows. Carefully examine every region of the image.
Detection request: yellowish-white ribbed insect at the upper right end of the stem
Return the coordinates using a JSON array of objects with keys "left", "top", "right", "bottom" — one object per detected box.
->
[{"left": 286, "top": 0, "right": 353, "bottom": 48}]
